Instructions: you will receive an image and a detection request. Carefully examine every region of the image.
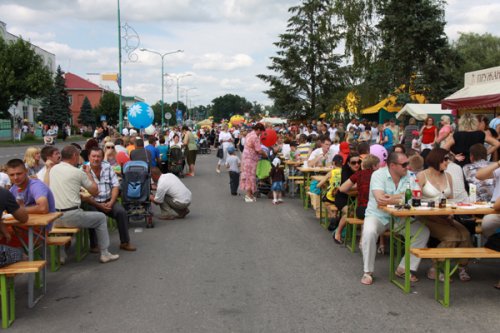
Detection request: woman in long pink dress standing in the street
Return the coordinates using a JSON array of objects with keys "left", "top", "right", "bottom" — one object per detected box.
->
[{"left": 240, "top": 123, "right": 267, "bottom": 202}]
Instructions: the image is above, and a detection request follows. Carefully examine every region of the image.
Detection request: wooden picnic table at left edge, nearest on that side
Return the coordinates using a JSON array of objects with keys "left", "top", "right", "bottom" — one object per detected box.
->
[{"left": 3, "top": 212, "right": 63, "bottom": 308}]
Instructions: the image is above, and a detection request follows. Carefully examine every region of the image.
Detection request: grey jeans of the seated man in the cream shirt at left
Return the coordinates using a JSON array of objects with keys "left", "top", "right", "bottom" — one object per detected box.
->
[{"left": 54, "top": 209, "right": 109, "bottom": 253}]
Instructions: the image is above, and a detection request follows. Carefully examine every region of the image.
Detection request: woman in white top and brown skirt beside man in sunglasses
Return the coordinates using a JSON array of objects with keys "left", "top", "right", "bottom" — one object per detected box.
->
[{"left": 417, "top": 148, "right": 472, "bottom": 281}]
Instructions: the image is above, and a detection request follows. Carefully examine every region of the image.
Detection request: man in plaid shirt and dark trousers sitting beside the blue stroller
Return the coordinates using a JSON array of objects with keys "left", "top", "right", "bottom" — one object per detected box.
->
[{"left": 84, "top": 147, "right": 136, "bottom": 251}]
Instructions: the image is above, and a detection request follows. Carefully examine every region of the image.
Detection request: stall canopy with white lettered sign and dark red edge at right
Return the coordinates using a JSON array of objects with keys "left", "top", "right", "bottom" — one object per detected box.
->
[{"left": 441, "top": 67, "right": 500, "bottom": 109}]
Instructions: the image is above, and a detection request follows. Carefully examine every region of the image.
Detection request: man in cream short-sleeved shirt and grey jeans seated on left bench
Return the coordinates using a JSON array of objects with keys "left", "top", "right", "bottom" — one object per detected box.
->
[{"left": 47, "top": 145, "right": 120, "bottom": 263}]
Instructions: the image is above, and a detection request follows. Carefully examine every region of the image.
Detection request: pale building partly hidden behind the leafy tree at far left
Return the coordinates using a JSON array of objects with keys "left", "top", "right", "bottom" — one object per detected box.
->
[{"left": 0, "top": 21, "right": 56, "bottom": 125}]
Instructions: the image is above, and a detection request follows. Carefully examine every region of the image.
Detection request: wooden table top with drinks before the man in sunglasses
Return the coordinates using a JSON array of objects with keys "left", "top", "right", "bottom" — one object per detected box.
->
[{"left": 379, "top": 205, "right": 498, "bottom": 217}]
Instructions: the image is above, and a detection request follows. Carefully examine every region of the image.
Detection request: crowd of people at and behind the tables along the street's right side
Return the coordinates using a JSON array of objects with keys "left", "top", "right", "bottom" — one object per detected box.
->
[{"left": 208, "top": 113, "right": 500, "bottom": 289}]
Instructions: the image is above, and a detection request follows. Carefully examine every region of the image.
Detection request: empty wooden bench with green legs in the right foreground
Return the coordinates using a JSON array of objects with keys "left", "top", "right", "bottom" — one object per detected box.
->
[{"left": 410, "top": 247, "right": 500, "bottom": 307}]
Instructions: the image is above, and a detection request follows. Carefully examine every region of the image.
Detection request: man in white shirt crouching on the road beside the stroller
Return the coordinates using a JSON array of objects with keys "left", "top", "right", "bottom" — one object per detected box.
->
[{"left": 150, "top": 167, "right": 192, "bottom": 220}]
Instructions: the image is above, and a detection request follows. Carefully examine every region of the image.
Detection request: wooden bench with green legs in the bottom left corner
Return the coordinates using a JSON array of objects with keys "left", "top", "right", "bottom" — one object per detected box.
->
[{"left": 0, "top": 260, "right": 45, "bottom": 328}]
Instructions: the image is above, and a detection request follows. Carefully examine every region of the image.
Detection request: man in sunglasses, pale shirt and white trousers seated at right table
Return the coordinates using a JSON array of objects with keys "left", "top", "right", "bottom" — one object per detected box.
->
[{"left": 361, "top": 152, "right": 430, "bottom": 285}]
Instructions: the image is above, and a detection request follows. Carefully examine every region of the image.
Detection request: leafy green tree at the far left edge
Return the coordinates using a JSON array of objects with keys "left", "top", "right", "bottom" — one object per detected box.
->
[{"left": 0, "top": 37, "right": 52, "bottom": 132}]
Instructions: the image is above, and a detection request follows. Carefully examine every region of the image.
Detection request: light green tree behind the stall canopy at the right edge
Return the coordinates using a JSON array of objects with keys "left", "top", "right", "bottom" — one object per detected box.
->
[{"left": 451, "top": 32, "right": 500, "bottom": 87}]
